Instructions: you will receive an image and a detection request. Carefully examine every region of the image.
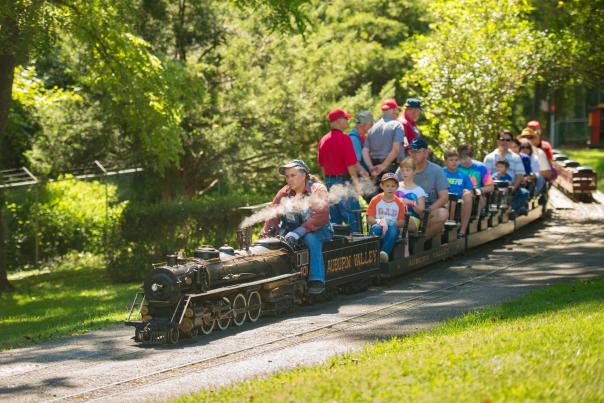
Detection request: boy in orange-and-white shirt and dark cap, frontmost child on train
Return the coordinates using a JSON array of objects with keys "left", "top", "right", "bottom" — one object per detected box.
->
[{"left": 367, "top": 172, "right": 405, "bottom": 263}]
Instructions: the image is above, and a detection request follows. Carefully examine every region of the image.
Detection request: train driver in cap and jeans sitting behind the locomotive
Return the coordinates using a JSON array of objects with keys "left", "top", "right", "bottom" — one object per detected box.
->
[{"left": 261, "top": 160, "right": 333, "bottom": 294}]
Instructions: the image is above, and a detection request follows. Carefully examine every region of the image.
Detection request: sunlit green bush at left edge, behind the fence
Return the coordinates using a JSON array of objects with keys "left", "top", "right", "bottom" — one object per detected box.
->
[{"left": 4, "top": 178, "right": 127, "bottom": 269}]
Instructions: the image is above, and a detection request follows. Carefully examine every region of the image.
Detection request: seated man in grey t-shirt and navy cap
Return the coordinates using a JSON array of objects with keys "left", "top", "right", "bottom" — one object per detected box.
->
[{"left": 396, "top": 138, "right": 449, "bottom": 239}]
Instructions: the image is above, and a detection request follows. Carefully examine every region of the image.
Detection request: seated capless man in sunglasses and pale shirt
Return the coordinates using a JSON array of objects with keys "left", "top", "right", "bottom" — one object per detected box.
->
[{"left": 484, "top": 130, "right": 529, "bottom": 215}]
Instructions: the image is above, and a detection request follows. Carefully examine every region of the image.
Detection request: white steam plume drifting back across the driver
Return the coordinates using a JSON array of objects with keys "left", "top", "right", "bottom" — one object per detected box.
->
[{"left": 239, "top": 178, "right": 376, "bottom": 228}]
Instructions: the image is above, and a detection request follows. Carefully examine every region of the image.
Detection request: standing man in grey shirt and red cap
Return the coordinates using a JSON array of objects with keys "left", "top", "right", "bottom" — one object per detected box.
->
[{"left": 363, "top": 99, "right": 405, "bottom": 177}]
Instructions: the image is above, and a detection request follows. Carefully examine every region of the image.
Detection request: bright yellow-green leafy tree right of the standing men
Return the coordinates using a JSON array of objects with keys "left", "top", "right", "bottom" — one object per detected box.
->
[{"left": 403, "top": 0, "right": 546, "bottom": 157}]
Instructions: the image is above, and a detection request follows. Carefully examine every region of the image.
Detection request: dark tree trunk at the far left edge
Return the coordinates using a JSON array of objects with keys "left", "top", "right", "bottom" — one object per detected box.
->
[{"left": 0, "top": 54, "right": 16, "bottom": 293}]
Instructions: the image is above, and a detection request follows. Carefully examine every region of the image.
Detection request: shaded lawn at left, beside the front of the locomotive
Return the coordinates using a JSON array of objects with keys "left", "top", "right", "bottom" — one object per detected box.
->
[{"left": 0, "top": 253, "right": 140, "bottom": 351}]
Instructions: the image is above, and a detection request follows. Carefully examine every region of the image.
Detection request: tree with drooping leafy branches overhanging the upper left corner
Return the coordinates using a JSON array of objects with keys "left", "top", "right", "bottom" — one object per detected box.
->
[{"left": 0, "top": 0, "right": 306, "bottom": 291}]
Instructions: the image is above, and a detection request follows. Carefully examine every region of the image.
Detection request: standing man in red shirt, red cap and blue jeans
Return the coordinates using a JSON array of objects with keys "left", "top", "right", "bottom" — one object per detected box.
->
[{"left": 317, "top": 108, "right": 364, "bottom": 232}]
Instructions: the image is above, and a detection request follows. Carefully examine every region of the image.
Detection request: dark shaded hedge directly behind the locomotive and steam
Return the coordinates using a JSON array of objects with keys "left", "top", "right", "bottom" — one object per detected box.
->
[{"left": 108, "top": 194, "right": 271, "bottom": 281}]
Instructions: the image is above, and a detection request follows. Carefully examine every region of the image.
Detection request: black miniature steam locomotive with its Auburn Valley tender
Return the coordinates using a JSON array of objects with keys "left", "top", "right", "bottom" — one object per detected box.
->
[{"left": 125, "top": 229, "right": 380, "bottom": 343}]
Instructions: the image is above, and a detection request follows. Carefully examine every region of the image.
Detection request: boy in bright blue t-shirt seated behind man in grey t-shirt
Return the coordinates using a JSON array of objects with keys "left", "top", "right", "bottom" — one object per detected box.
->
[{"left": 443, "top": 151, "right": 474, "bottom": 238}]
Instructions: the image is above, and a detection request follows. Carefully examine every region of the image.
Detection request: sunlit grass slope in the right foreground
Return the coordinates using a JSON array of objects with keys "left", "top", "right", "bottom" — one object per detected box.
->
[{"left": 179, "top": 278, "right": 604, "bottom": 402}]
